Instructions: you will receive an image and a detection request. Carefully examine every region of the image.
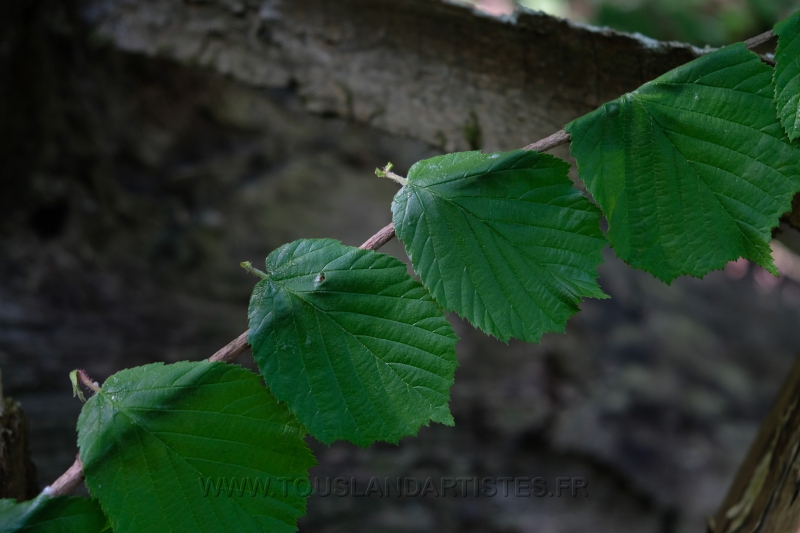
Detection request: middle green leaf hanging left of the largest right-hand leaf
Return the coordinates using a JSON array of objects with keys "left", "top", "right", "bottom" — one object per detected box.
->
[{"left": 392, "top": 150, "right": 606, "bottom": 342}]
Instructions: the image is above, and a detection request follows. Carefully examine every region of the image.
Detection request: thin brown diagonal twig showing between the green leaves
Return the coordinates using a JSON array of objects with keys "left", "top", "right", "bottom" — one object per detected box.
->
[{"left": 45, "top": 22, "right": 788, "bottom": 496}]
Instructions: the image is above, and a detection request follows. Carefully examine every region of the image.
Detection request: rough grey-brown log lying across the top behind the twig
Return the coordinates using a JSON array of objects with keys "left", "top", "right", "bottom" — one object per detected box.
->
[{"left": 85, "top": 0, "right": 702, "bottom": 151}]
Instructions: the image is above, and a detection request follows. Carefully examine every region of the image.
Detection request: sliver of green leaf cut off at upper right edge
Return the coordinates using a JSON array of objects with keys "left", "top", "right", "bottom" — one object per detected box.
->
[{"left": 773, "top": 11, "right": 800, "bottom": 140}]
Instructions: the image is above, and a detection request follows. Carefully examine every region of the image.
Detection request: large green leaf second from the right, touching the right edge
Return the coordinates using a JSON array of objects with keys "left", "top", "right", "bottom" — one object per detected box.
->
[{"left": 566, "top": 43, "right": 800, "bottom": 283}]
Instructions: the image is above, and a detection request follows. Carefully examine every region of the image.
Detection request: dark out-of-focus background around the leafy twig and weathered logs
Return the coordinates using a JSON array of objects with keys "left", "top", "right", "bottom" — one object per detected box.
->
[{"left": 0, "top": 0, "right": 800, "bottom": 533}]
